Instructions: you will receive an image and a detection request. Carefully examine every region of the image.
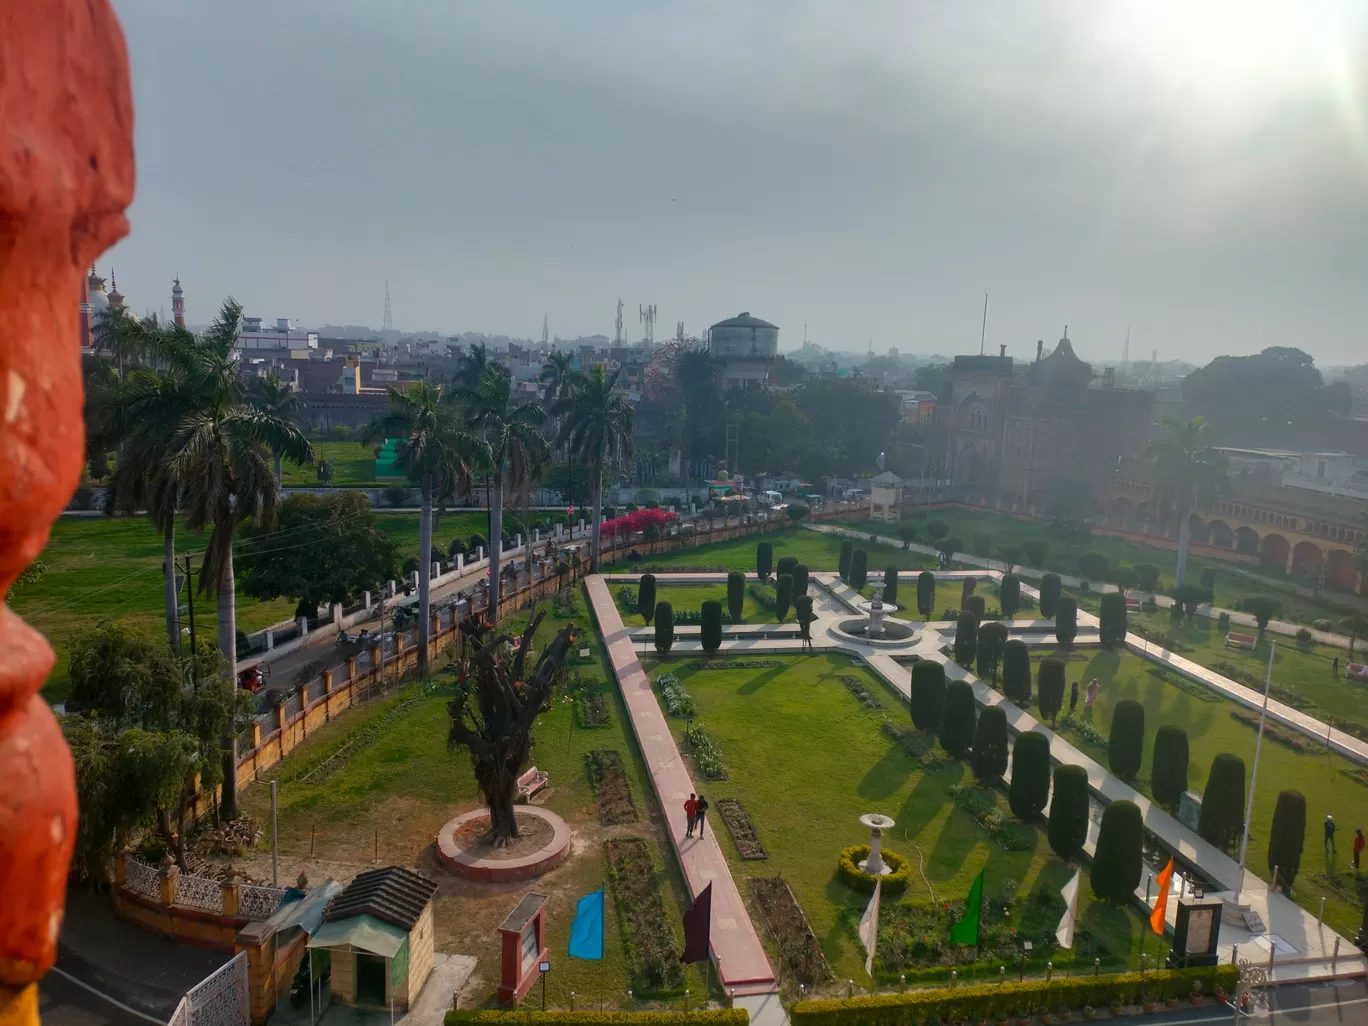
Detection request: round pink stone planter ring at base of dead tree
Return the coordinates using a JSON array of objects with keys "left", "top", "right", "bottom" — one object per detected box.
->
[{"left": 436, "top": 806, "right": 570, "bottom": 882}]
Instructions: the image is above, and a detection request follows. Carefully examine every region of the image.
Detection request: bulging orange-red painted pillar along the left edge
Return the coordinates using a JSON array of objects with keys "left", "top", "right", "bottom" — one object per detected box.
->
[{"left": 0, "top": 0, "right": 133, "bottom": 1022}]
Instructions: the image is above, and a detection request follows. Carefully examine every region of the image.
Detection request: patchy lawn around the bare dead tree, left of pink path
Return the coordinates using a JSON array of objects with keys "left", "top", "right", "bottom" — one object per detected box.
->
[{"left": 242, "top": 596, "right": 707, "bottom": 1010}]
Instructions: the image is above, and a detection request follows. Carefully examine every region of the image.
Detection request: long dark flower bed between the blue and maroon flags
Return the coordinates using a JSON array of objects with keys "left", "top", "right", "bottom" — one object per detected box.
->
[{"left": 603, "top": 837, "right": 684, "bottom": 997}]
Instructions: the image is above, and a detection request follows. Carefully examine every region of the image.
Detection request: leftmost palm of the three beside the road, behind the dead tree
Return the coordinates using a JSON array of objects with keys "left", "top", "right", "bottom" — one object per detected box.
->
[{"left": 361, "top": 380, "right": 488, "bottom": 674}]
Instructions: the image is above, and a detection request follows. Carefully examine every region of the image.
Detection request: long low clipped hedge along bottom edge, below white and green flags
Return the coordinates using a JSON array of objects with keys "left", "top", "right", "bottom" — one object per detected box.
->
[{"left": 782, "top": 966, "right": 1239, "bottom": 1026}]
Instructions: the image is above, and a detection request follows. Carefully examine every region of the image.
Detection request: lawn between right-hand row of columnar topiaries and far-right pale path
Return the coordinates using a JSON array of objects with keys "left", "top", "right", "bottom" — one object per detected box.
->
[{"left": 1031, "top": 646, "right": 1368, "bottom": 937}]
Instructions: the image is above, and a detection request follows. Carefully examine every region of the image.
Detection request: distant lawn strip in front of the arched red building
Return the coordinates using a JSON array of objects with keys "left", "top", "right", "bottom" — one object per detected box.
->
[{"left": 870, "top": 509, "right": 1352, "bottom": 624}]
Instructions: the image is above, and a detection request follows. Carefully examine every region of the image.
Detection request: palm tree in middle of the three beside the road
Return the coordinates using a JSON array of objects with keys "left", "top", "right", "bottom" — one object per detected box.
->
[{"left": 460, "top": 364, "right": 550, "bottom": 622}]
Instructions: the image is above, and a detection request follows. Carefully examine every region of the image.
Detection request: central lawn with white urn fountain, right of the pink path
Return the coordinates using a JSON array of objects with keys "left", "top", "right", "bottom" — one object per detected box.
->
[{"left": 647, "top": 655, "right": 1141, "bottom": 981}]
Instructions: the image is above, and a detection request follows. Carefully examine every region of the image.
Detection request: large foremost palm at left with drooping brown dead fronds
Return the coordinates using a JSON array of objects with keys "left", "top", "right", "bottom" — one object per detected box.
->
[{"left": 159, "top": 297, "right": 313, "bottom": 819}]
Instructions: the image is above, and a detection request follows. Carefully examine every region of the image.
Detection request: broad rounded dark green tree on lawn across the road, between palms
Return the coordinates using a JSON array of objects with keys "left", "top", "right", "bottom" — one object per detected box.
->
[{"left": 237, "top": 491, "right": 399, "bottom": 609}]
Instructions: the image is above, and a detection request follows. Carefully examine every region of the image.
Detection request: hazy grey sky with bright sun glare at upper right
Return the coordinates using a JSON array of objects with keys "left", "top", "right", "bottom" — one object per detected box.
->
[{"left": 100, "top": 0, "right": 1368, "bottom": 364}]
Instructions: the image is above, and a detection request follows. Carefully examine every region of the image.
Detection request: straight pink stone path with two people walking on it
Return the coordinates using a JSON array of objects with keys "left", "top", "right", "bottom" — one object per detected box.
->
[{"left": 586, "top": 575, "right": 778, "bottom": 996}]
